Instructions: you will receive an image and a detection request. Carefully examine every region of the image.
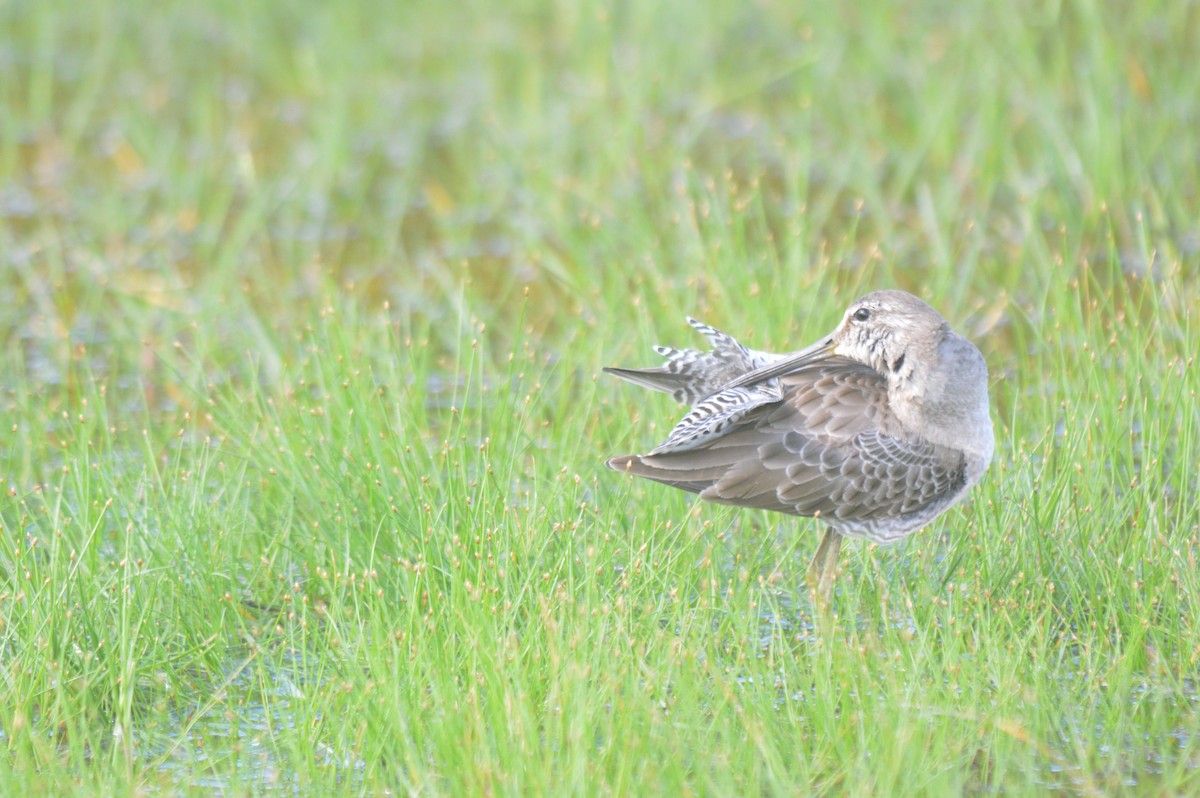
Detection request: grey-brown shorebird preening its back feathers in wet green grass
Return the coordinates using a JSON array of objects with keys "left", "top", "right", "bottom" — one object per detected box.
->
[{"left": 605, "top": 290, "right": 994, "bottom": 605}]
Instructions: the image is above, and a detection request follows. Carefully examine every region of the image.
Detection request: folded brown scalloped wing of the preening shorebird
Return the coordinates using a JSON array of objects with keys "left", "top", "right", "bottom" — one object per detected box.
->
[{"left": 610, "top": 359, "right": 965, "bottom": 536}]
